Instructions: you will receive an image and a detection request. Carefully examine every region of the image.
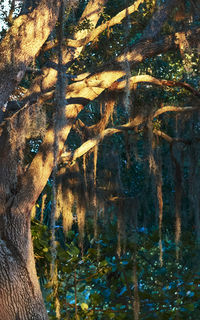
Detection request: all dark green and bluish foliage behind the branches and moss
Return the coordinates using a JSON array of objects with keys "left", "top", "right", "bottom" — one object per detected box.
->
[{"left": 1, "top": 0, "right": 200, "bottom": 320}]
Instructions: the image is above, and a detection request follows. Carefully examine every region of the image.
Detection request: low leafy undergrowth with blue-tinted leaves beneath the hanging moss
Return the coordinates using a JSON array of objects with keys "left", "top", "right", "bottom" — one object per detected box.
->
[{"left": 32, "top": 222, "right": 200, "bottom": 320}]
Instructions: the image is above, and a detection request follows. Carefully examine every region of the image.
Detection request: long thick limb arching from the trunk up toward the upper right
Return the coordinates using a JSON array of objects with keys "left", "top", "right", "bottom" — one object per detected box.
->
[{"left": 6, "top": 20, "right": 200, "bottom": 212}]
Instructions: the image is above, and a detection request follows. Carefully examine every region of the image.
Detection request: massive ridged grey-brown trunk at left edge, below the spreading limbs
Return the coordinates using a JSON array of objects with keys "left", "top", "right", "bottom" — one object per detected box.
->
[{"left": 0, "top": 122, "right": 48, "bottom": 320}]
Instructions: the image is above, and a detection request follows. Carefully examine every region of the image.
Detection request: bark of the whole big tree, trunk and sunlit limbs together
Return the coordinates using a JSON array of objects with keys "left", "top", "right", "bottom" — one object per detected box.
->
[{"left": 0, "top": 0, "right": 200, "bottom": 320}]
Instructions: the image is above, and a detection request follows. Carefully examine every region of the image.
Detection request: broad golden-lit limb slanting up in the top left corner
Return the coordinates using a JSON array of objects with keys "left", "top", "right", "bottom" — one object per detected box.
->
[{"left": 0, "top": 0, "right": 60, "bottom": 107}]
